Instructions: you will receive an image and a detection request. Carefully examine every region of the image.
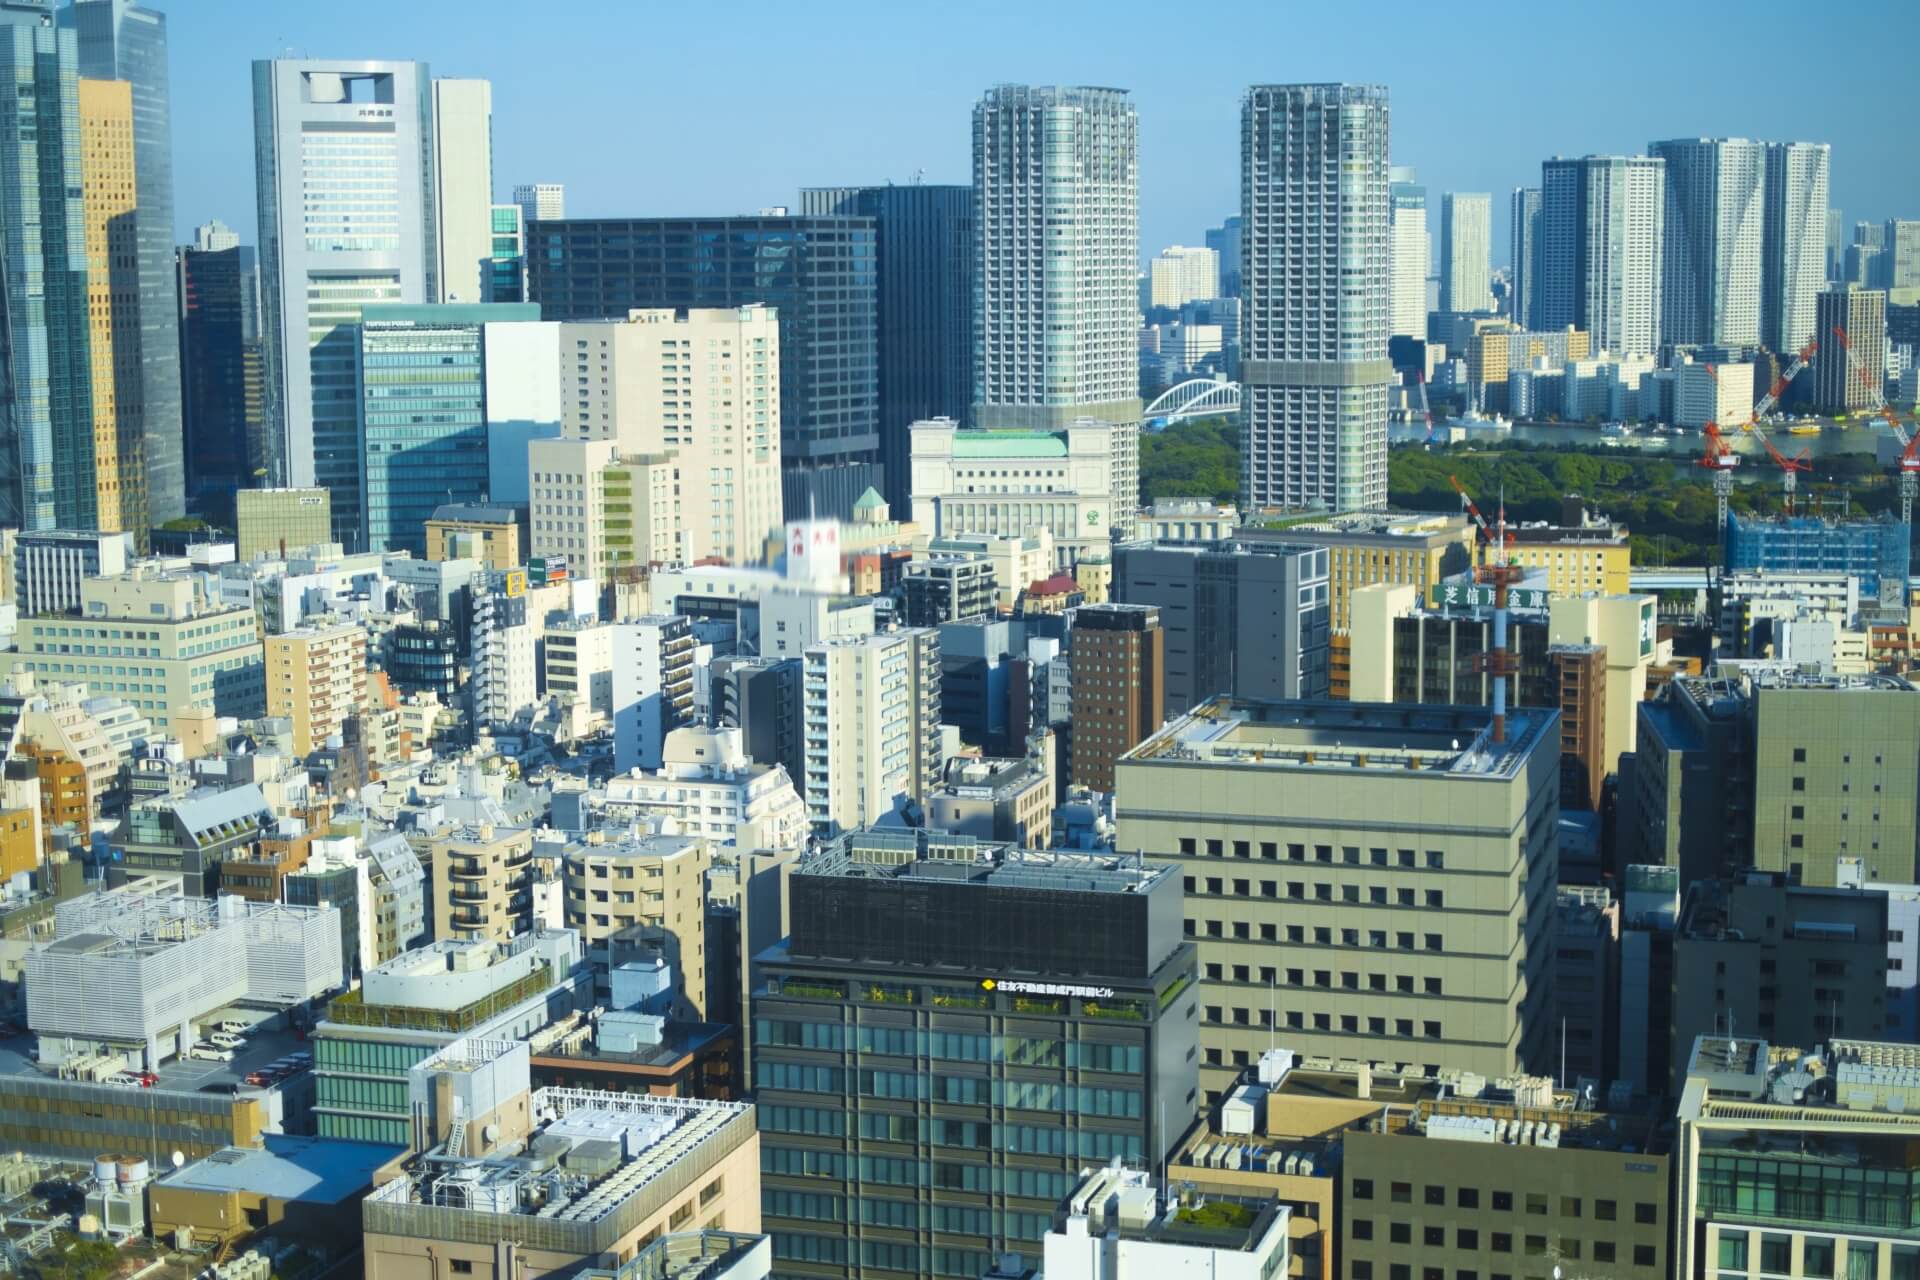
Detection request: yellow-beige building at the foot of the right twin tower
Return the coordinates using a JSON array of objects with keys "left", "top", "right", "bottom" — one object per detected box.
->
[{"left": 1238, "top": 512, "right": 1473, "bottom": 631}]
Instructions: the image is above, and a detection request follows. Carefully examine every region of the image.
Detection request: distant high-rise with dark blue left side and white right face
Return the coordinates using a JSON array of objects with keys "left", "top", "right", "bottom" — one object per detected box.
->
[{"left": 1532, "top": 155, "right": 1667, "bottom": 355}]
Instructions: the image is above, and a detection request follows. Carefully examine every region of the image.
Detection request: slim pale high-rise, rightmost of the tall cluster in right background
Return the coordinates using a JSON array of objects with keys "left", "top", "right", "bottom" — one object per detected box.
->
[{"left": 1761, "top": 142, "right": 1832, "bottom": 355}]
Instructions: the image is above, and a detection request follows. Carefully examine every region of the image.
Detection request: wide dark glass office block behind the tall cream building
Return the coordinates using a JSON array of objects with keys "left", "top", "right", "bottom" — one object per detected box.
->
[{"left": 526, "top": 215, "right": 881, "bottom": 520}]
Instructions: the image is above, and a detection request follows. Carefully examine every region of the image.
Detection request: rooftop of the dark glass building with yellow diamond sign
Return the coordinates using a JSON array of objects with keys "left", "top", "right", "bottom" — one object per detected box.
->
[{"left": 793, "top": 831, "right": 1173, "bottom": 894}]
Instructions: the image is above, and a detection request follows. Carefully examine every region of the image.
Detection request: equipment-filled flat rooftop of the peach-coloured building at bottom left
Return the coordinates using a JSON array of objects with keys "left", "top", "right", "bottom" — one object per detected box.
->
[{"left": 363, "top": 1088, "right": 753, "bottom": 1255}]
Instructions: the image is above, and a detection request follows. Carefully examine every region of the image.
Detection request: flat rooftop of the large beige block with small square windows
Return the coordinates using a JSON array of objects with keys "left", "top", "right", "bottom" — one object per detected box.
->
[{"left": 1121, "top": 697, "right": 1555, "bottom": 777}]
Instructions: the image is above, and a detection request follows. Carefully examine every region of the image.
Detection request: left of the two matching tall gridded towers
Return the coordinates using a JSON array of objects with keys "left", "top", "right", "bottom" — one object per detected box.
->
[{"left": 973, "top": 84, "right": 1140, "bottom": 430}]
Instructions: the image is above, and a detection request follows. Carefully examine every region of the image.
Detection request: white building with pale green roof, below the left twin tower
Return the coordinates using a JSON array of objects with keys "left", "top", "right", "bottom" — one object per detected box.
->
[{"left": 912, "top": 418, "right": 1140, "bottom": 566}]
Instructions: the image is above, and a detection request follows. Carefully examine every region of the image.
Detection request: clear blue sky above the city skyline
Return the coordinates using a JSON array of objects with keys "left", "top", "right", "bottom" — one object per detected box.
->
[{"left": 172, "top": 0, "right": 1920, "bottom": 261}]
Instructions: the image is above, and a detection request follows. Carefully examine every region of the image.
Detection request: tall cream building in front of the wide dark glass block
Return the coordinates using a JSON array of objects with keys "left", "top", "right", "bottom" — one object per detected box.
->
[{"left": 561, "top": 305, "right": 781, "bottom": 564}]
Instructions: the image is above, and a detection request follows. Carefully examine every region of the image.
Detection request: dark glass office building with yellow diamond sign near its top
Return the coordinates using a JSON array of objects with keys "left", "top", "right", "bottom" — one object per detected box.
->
[{"left": 751, "top": 831, "right": 1198, "bottom": 1280}]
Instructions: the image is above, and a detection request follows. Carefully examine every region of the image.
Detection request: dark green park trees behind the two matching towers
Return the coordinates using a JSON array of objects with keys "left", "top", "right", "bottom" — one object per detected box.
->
[{"left": 1140, "top": 418, "right": 1895, "bottom": 564}]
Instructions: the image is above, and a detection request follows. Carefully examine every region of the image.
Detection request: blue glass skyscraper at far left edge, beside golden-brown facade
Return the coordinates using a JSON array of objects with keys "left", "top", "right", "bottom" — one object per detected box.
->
[{"left": 0, "top": 0, "right": 98, "bottom": 530}]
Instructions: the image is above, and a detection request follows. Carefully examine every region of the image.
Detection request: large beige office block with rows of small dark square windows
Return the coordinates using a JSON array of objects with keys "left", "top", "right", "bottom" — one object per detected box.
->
[{"left": 1114, "top": 699, "right": 1559, "bottom": 1094}]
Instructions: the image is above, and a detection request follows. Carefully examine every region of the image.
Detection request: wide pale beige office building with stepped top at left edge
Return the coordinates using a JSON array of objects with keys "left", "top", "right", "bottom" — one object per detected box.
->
[{"left": 0, "top": 566, "right": 267, "bottom": 731}]
